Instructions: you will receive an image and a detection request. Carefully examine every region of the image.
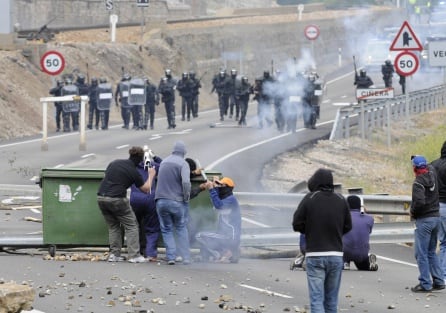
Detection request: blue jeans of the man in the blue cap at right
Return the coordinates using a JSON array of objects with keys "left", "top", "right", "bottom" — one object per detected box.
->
[{"left": 415, "top": 217, "right": 444, "bottom": 290}]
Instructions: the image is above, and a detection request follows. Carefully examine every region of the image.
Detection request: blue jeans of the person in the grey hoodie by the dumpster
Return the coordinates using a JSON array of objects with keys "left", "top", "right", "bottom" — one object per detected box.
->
[{"left": 156, "top": 199, "right": 190, "bottom": 261}]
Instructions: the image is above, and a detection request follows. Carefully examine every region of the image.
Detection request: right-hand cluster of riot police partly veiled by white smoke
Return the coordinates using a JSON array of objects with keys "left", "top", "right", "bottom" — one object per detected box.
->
[{"left": 211, "top": 68, "right": 323, "bottom": 132}]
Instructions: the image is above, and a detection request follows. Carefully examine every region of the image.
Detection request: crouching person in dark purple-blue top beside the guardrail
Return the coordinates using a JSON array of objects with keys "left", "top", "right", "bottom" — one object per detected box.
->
[{"left": 342, "top": 195, "right": 378, "bottom": 271}]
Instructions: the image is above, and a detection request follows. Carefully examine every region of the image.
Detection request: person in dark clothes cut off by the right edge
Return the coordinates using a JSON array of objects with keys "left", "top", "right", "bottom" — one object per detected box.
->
[{"left": 431, "top": 141, "right": 446, "bottom": 281}]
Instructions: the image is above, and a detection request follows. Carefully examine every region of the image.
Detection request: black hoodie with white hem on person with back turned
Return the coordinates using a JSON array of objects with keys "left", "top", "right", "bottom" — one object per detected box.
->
[{"left": 293, "top": 169, "right": 352, "bottom": 257}]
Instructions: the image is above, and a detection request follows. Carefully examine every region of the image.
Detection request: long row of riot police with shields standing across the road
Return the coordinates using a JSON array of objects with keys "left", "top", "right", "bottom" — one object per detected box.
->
[{"left": 49, "top": 69, "right": 323, "bottom": 132}]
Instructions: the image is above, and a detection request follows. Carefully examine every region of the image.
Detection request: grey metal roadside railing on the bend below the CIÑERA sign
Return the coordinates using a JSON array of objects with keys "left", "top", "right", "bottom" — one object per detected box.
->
[{"left": 330, "top": 85, "right": 446, "bottom": 140}]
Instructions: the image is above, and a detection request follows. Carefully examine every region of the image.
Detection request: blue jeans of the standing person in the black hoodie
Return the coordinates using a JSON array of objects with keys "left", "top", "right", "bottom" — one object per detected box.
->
[{"left": 306, "top": 256, "right": 344, "bottom": 313}]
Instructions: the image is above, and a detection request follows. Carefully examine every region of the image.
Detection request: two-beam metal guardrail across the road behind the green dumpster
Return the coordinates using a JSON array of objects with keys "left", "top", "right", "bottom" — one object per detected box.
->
[{"left": 0, "top": 185, "right": 414, "bottom": 247}]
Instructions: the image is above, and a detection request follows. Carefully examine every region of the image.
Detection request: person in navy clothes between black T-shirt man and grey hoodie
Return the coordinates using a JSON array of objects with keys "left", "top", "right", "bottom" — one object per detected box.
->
[{"left": 130, "top": 156, "right": 162, "bottom": 262}]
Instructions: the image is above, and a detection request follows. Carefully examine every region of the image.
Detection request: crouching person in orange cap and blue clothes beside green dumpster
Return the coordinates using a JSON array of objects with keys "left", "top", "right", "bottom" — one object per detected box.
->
[{"left": 195, "top": 177, "right": 242, "bottom": 263}]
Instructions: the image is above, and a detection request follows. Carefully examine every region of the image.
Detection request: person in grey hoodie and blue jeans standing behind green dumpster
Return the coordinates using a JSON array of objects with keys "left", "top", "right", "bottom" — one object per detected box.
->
[{"left": 155, "top": 141, "right": 191, "bottom": 265}]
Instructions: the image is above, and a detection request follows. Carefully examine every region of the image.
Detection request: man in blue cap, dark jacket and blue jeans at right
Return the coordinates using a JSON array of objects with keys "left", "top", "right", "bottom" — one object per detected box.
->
[{"left": 410, "top": 155, "right": 445, "bottom": 292}]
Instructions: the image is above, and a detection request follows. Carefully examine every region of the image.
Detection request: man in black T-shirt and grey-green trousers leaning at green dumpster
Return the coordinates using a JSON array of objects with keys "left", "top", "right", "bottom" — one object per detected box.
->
[{"left": 97, "top": 147, "right": 156, "bottom": 263}]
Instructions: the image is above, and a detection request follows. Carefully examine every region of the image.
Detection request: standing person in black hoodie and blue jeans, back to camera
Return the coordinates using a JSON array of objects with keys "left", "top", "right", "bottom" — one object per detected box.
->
[{"left": 292, "top": 169, "right": 352, "bottom": 313}]
